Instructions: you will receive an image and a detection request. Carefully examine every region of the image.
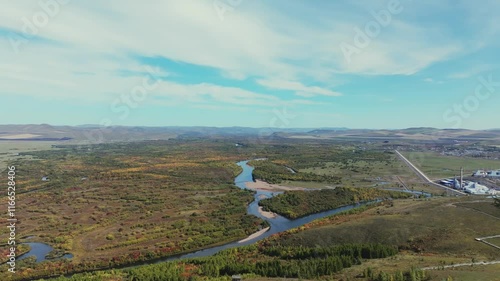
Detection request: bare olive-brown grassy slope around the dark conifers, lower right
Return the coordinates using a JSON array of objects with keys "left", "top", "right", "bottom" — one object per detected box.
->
[{"left": 277, "top": 198, "right": 500, "bottom": 281}]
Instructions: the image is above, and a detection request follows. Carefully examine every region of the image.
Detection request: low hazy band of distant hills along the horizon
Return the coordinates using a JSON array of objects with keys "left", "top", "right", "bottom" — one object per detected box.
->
[{"left": 0, "top": 124, "right": 500, "bottom": 143}]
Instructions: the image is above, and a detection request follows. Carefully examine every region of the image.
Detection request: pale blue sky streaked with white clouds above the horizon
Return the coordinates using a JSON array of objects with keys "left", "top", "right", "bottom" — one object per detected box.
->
[{"left": 0, "top": 0, "right": 500, "bottom": 129}]
